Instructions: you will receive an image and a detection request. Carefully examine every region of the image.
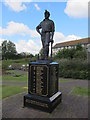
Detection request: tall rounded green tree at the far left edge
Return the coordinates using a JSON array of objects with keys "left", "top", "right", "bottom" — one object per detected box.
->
[{"left": 2, "top": 40, "right": 17, "bottom": 60}]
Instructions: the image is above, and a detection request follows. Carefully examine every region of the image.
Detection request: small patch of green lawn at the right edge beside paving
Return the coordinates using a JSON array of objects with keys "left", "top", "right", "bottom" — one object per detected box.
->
[{"left": 72, "top": 87, "right": 90, "bottom": 96}]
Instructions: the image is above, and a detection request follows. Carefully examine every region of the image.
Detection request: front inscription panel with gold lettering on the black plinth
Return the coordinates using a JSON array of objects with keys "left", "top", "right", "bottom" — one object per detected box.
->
[{"left": 30, "top": 65, "right": 48, "bottom": 96}]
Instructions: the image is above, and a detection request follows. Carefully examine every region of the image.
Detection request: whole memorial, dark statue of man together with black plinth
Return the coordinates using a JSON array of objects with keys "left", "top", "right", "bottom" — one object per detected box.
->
[{"left": 23, "top": 10, "right": 62, "bottom": 113}]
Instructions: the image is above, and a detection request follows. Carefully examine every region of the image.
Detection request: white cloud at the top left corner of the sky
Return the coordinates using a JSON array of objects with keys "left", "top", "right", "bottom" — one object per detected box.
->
[{"left": 4, "top": 0, "right": 31, "bottom": 12}]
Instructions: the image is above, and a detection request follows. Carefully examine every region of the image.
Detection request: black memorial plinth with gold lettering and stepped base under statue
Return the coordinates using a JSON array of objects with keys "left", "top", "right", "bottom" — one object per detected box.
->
[{"left": 24, "top": 61, "right": 62, "bottom": 112}]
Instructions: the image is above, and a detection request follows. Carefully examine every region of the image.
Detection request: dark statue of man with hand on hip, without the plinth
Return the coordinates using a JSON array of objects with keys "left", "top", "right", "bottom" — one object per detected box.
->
[{"left": 36, "top": 10, "right": 55, "bottom": 60}]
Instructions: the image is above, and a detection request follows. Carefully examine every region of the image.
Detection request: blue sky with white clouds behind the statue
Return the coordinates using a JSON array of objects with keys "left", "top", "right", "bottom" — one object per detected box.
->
[{"left": 0, "top": 0, "right": 88, "bottom": 54}]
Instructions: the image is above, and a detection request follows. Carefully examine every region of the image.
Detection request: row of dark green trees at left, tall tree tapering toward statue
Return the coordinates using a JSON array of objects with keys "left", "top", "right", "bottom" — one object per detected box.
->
[{"left": 2, "top": 40, "right": 34, "bottom": 60}]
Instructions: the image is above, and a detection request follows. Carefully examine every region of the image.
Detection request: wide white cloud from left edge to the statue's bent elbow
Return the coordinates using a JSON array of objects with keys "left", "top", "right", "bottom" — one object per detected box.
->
[{"left": 0, "top": 21, "right": 39, "bottom": 37}]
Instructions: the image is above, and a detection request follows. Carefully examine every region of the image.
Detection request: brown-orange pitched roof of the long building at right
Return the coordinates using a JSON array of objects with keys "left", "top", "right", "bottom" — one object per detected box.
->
[{"left": 53, "top": 37, "right": 90, "bottom": 48}]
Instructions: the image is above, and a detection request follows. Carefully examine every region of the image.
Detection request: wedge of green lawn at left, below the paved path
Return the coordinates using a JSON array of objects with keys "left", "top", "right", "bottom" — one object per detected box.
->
[{"left": 2, "top": 85, "right": 27, "bottom": 99}]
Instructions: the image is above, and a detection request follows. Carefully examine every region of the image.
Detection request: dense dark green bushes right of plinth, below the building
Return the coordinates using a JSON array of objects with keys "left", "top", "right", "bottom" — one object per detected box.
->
[{"left": 54, "top": 44, "right": 90, "bottom": 79}]
